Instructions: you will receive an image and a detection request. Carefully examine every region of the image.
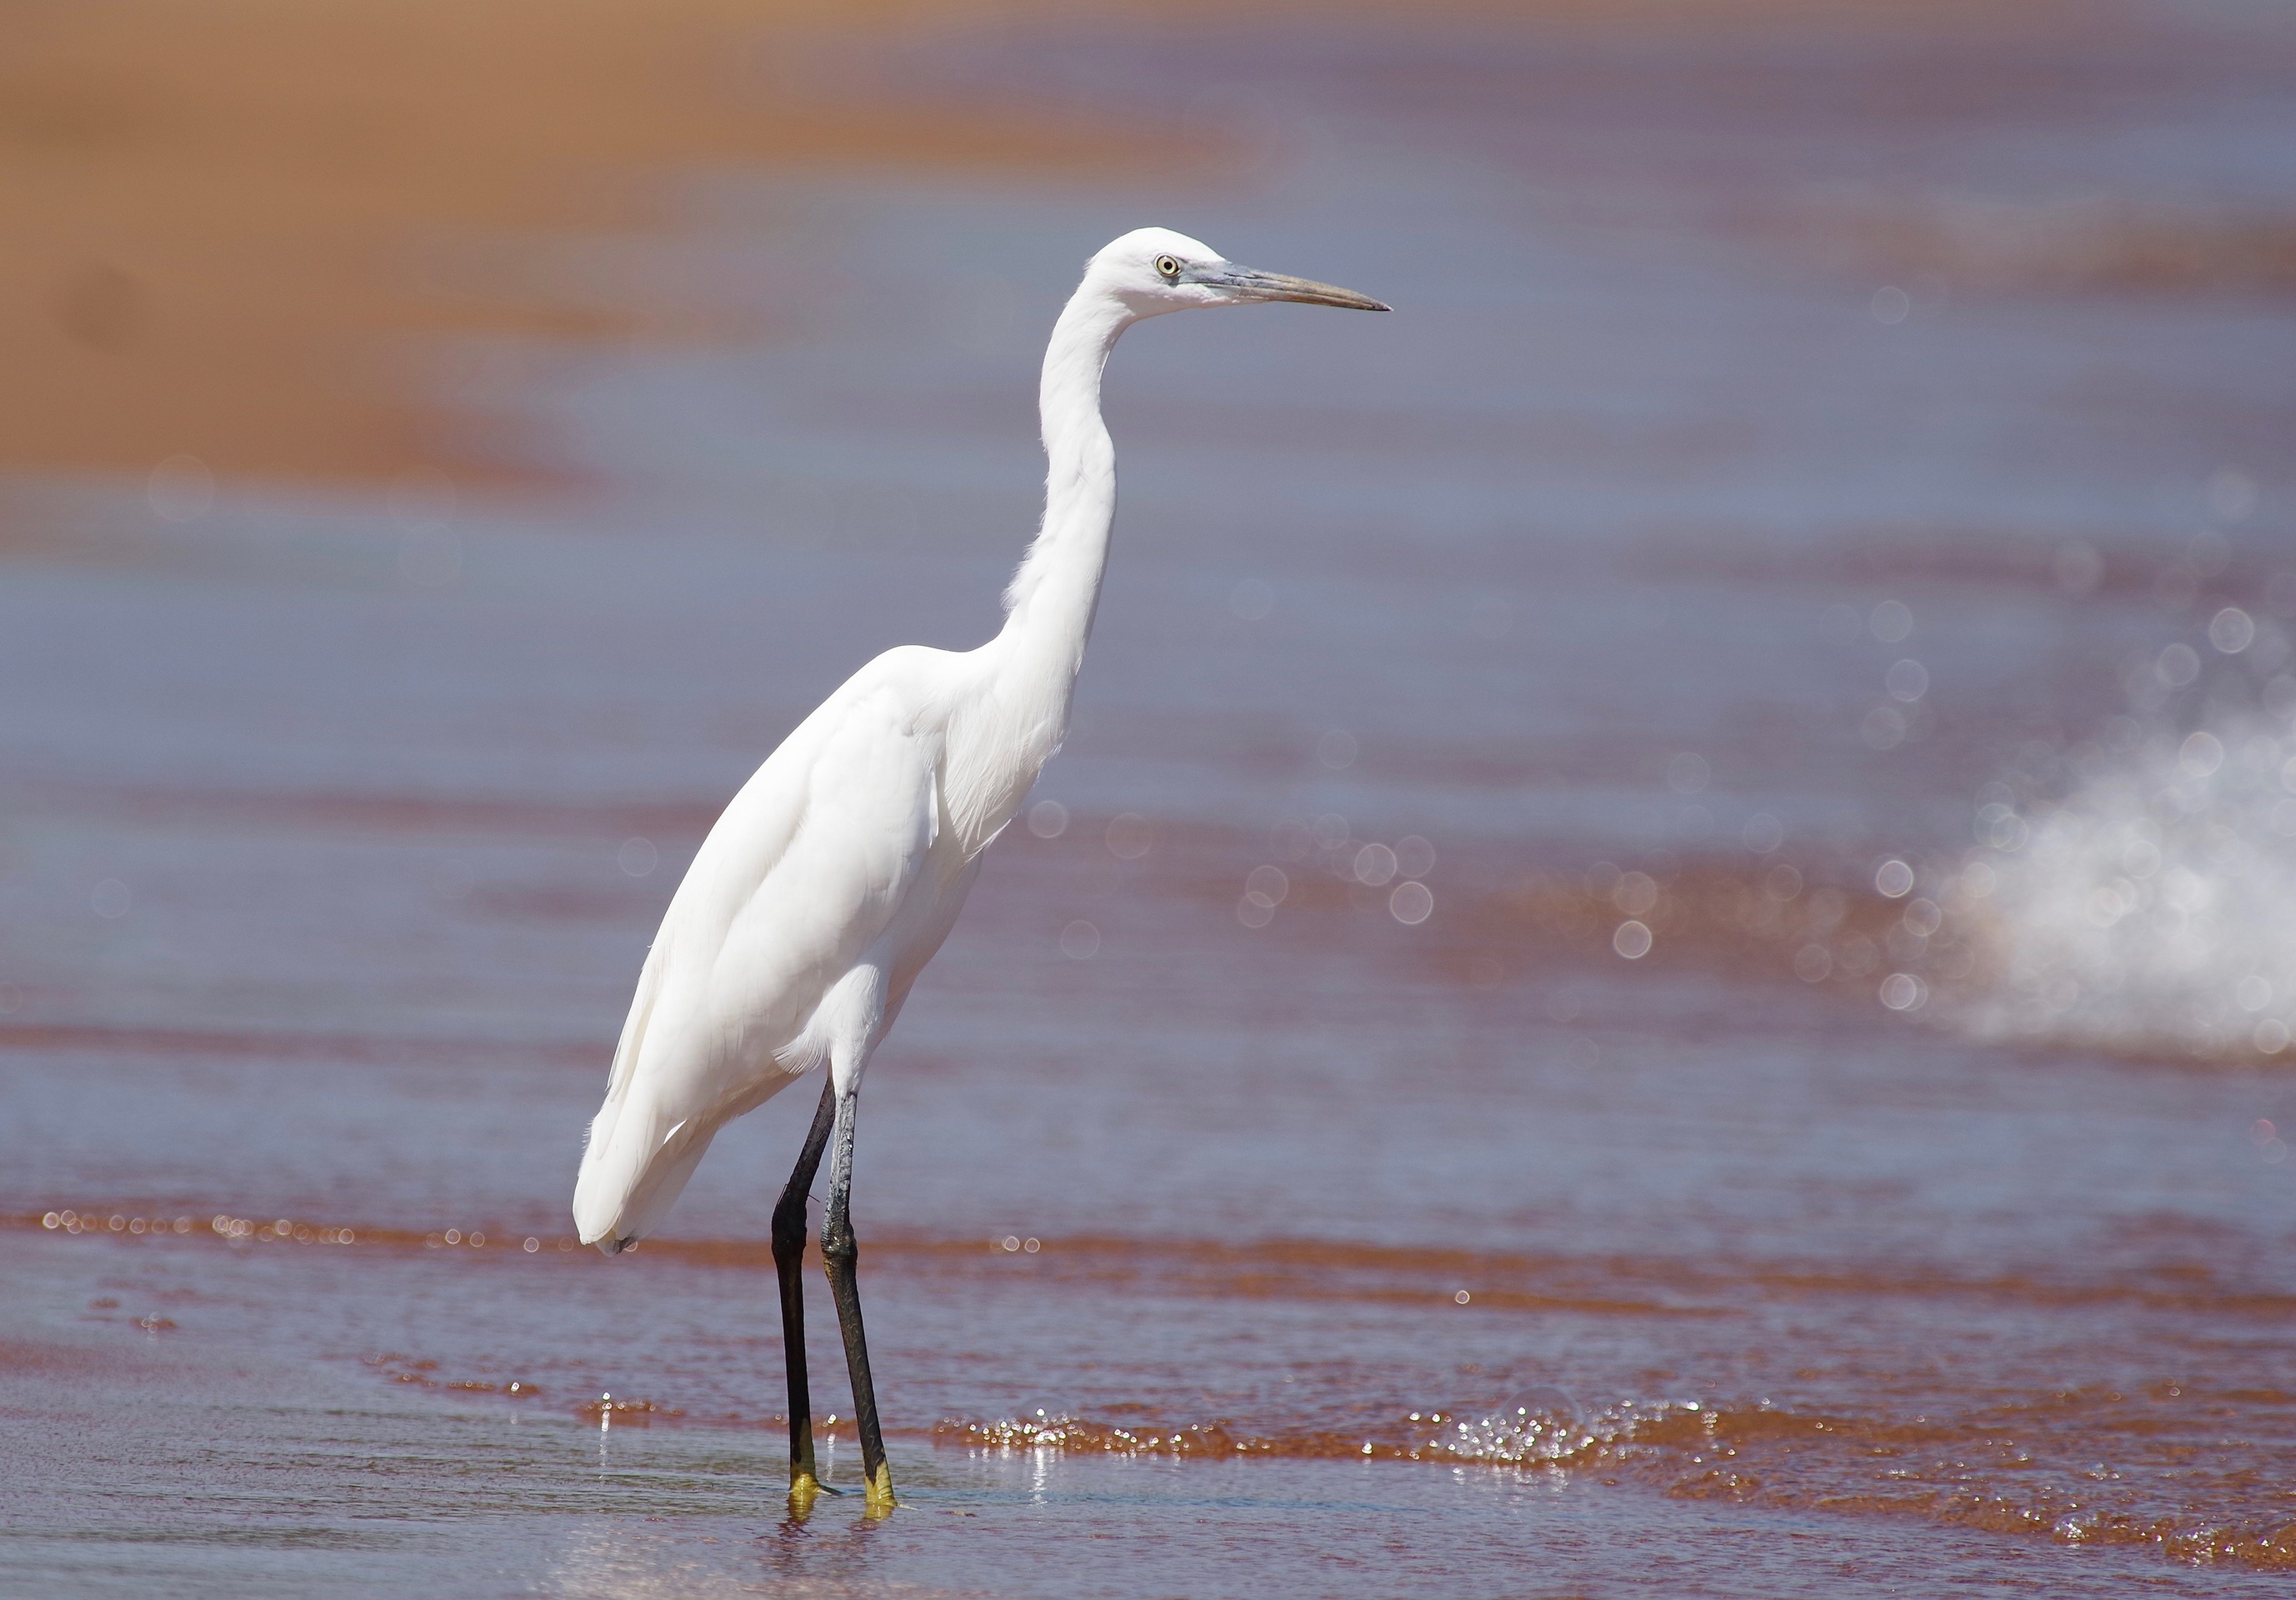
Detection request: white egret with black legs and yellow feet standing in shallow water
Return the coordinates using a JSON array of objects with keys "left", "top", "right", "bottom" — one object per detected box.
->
[{"left": 574, "top": 228, "right": 1387, "bottom": 1508}]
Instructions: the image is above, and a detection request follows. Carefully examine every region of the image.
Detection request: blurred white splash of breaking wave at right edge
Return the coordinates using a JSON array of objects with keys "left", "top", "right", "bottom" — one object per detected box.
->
[{"left": 1938, "top": 608, "right": 2296, "bottom": 1056}]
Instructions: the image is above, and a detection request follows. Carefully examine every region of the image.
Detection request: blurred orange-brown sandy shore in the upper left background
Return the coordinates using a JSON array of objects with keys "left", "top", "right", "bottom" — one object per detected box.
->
[{"left": 0, "top": 0, "right": 2053, "bottom": 493}]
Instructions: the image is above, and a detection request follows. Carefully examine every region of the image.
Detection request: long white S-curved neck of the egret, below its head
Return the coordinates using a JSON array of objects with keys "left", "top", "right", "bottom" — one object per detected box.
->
[{"left": 997, "top": 285, "right": 1134, "bottom": 674}]
